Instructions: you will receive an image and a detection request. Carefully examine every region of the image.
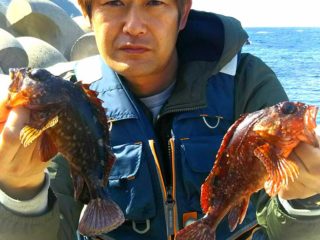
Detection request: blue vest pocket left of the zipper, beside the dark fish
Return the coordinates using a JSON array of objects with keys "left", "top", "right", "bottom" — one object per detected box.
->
[{"left": 109, "top": 142, "right": 156, "bottom": 221}]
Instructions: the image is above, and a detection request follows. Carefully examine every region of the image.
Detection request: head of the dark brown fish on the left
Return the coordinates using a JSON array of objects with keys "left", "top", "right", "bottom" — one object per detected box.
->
[{"left": 7, "top": 68, "right": 59, "bottom": 108}]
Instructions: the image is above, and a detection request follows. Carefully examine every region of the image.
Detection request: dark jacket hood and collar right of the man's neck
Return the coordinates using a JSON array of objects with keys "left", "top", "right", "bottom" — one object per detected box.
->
[{"left": 161, "top": 10, "right": 248, "bottom": 114}]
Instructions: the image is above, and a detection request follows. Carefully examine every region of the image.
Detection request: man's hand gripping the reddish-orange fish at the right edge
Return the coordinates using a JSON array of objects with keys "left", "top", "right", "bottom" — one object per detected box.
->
[{"left": 279, "top": 127, "right": 320, "bottom": 200}]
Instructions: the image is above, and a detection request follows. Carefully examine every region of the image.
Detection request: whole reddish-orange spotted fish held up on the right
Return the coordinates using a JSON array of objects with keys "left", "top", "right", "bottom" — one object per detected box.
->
[{"left": 176, "top": 102, "right": 319, "bottom": 240}]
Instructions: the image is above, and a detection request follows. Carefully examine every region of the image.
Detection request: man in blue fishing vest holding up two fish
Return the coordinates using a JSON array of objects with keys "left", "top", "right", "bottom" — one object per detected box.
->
[{"left": 0, "top": 0, "right": 320, "bottom": 240}]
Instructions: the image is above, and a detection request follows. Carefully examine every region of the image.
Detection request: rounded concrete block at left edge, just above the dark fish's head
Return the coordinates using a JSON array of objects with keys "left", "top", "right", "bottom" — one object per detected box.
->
[{"left": 0, "top": 28, "right": 28, "bottom": 74}]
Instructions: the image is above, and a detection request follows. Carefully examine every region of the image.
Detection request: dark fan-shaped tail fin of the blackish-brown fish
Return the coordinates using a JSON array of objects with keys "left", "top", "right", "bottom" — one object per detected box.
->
[{"left": 79, "top": 198, "right": 125, "bottom": 236}]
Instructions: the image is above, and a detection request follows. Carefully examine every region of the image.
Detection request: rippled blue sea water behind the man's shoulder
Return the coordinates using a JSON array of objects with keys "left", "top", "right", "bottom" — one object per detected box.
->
[{"left": 243, "top": 28, "right": 320, "bottom": 124}]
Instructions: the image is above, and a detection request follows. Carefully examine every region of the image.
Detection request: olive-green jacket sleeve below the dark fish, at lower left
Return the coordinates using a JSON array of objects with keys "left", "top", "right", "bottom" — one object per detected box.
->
[{"left": 0, "top": 156, "right": 82, "bottom": 240}]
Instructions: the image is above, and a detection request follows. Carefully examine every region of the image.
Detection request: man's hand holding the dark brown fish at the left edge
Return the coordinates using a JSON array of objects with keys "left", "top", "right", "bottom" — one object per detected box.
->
[{"left": 0, "top": 79, "right": 47, "bottom": 200}]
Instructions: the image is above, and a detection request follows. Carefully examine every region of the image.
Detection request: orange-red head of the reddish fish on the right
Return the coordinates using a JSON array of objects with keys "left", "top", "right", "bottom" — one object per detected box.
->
[{"left": 253, "top": 101, "right": 319, "bottom": 147}]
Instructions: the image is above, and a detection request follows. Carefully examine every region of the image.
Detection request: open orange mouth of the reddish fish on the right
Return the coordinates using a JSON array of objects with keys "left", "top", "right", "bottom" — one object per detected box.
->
[{"left": 304, "top": 106, "right": 319, "bottom": 148}]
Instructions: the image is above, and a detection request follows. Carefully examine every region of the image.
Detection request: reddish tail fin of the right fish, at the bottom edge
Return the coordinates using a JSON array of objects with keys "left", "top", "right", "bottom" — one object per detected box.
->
[{"left": 175, "top": 219, "right": 216, "bottom": 240}]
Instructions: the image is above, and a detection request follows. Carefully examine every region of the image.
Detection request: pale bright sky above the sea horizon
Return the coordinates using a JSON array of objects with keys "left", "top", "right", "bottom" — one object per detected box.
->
[{"left": 193, "top": 0, "right": 320, "bottom": 27}]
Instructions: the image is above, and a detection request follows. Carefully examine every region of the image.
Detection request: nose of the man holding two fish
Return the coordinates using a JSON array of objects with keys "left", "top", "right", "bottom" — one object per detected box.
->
[{"left": 123, "top": 7, "right": 147, "bottom": 36}]
